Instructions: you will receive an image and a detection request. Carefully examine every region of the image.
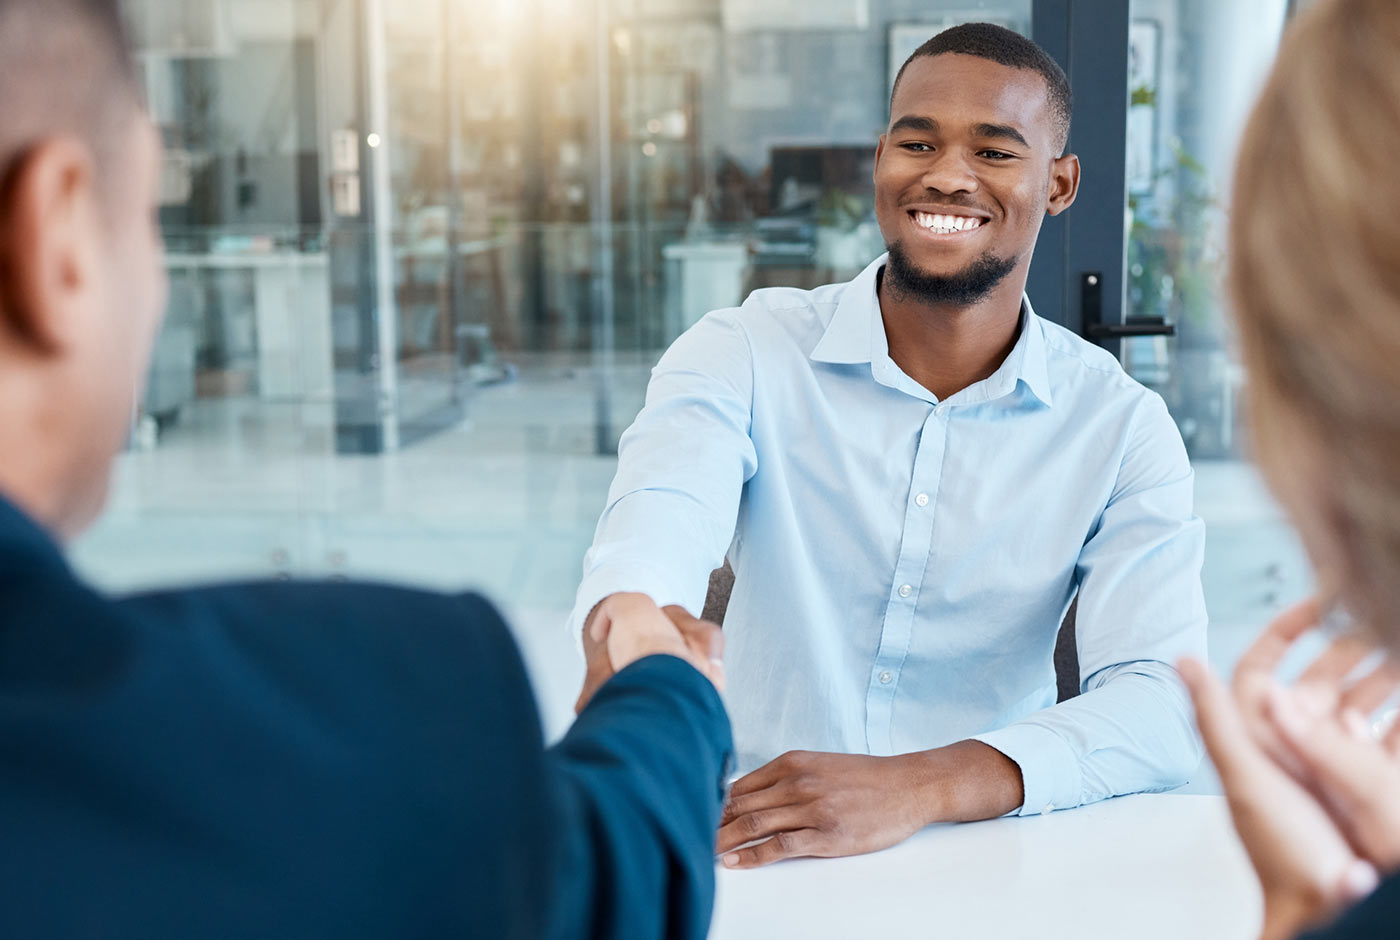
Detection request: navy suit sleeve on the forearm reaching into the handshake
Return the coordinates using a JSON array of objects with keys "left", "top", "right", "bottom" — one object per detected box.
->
[{"left": 549, "top": 656, "right": 732, "bottom": 940}]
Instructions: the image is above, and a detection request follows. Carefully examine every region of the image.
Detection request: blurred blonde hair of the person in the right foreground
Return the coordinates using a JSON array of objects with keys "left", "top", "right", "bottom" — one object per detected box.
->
[{"left": 1229, "top": 0, "right": 1400, "bottom": 650}]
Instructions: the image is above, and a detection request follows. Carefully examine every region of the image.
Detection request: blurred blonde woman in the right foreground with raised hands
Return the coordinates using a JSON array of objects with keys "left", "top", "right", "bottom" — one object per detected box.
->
[{"left": 1182, "top": 0, "right": 1400, "bottom": 940}]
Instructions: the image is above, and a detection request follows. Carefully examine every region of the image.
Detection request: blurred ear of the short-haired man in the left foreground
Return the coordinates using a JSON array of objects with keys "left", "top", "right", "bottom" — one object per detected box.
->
[{"left": 0, "top": 137, "right": 101, "bottom": 354}]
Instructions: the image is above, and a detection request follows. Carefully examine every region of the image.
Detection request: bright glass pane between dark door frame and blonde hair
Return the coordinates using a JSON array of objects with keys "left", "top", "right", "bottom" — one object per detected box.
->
[{"left": 1121, "top": 0, "right": 1310, "bottom": 683}]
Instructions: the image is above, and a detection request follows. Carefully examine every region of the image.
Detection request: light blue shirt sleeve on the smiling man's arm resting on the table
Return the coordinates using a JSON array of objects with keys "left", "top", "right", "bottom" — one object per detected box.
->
[{"left": 974, "top": 394, "right": 1207, "bottom": 814}]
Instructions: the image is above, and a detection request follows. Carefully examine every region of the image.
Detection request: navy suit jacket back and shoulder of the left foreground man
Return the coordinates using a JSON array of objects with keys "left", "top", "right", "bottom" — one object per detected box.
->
[{"left": 0, "top": 565, "right": 559, "bottom": 937}]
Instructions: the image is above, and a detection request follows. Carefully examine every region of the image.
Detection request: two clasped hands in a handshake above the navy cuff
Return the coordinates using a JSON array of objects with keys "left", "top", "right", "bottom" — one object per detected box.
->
[{"left": 574, "top": 594, "right": 724, "bottom": 712}]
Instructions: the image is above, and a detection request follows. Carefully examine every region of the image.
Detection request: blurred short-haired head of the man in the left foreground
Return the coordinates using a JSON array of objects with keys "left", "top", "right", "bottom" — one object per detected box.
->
[{"left": 0, "top": 0, "right": 165, "bottom": 537}]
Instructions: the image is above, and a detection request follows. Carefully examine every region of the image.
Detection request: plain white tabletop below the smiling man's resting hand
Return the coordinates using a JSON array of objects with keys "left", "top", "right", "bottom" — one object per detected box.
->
[{"left": 710, "top": 794, "right": 1261, "bottom": 940}]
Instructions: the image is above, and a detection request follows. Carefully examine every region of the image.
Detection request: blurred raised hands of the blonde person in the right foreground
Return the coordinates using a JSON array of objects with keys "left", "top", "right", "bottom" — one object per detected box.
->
[{"left": 1182, "top": 601, "right": 1400, "bottom": 940}]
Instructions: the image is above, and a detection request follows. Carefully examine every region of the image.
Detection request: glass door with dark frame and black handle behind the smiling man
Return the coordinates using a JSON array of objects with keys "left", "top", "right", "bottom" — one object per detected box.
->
[{"left": 1052, "top": 0, "right": 1312, "bottom": 792}]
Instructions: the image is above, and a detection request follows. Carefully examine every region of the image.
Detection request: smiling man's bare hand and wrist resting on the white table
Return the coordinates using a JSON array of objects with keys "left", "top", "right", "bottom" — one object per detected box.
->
[{"left": 715, "top": 741, "right": 1022, "bottom": 869}]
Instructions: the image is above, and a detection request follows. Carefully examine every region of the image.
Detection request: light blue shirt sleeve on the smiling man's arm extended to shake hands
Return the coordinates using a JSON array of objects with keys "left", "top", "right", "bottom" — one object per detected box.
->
[{"left": 567, "top": 310, "right": 757, "bottom": 640}]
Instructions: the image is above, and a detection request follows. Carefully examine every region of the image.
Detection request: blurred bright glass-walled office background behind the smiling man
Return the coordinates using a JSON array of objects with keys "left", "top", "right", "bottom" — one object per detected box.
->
[{"left": 76, "top": 0, "right": 1309, "bottom": 750}]
